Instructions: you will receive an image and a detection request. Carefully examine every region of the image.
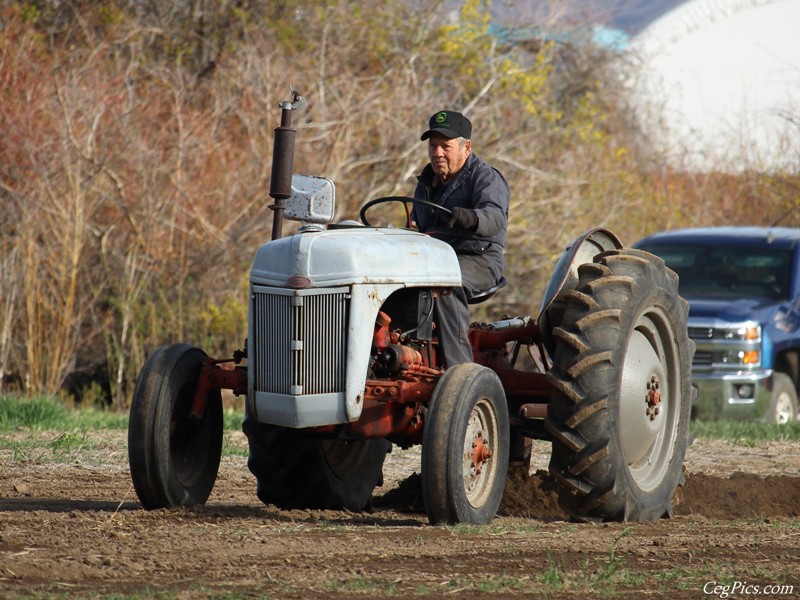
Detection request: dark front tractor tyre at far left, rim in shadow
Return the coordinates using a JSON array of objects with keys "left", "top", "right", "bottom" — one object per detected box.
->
[{"left": 128, "top": 344, "right": 222, "bottom": 510}]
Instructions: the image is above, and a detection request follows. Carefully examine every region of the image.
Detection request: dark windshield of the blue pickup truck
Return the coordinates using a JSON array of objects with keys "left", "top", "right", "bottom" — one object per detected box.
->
[{"left": 641, "top": 244, "right": 792, "bottom": 300}]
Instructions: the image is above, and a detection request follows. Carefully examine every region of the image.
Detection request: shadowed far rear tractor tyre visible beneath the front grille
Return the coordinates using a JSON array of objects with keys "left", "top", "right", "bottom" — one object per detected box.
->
[{"left": 242, "top": 414, "right": 391, "bottom": 512}]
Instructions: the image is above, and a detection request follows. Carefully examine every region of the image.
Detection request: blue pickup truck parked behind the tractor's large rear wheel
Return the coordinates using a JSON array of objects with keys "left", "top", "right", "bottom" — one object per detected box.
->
[{"left": 634, "top": 227, "right": 800, "bottom": 423}]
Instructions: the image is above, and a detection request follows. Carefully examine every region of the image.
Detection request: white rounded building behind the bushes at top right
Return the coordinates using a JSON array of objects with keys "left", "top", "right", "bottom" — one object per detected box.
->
[{"left": 630, "top": 0, "right": 800, "bottom": 172}]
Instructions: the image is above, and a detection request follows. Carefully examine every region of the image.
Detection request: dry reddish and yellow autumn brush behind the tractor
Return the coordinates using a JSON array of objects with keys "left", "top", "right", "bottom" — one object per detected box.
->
[{"left": 0, "top": 0, "right": 800, "bottom": 408}]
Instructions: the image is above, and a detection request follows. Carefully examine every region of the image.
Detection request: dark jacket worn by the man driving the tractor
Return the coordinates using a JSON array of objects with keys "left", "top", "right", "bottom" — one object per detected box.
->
[{"left": 412, "top": 154, "right": 511, "bottom": 256}]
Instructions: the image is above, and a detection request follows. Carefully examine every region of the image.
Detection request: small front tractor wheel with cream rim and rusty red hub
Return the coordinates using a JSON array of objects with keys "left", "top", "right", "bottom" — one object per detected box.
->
[{"left": 422, "top": 363, "right": 510, "bottom": 525}]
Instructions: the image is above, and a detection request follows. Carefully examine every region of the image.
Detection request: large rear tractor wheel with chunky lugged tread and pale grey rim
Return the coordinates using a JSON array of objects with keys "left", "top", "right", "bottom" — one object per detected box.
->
[{"left": 545, "top": 250, "right": 694, "bottom": 521}]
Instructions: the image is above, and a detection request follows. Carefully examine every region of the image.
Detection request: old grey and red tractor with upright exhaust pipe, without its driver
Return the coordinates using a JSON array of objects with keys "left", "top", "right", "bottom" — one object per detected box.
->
[{"left": 128, "top": 91, "right": 694, "bottom": 524}]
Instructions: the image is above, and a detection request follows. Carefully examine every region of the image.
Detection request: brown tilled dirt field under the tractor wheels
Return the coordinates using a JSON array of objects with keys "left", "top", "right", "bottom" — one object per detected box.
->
[{"left": 0, "top": 432, "right": 800, "bottom": 599}]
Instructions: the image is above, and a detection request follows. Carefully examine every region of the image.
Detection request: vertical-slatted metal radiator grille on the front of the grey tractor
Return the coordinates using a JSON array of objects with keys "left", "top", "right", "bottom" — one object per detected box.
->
[{"left": 251, "top": 286, "right": 349, "bottom": 396}]
